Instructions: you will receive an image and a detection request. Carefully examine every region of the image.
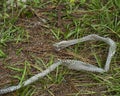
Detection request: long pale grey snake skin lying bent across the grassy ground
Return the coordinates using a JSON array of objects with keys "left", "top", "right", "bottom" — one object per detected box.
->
[{"left": 0, "top": 34, "right": 116, "bottom": 94}]
